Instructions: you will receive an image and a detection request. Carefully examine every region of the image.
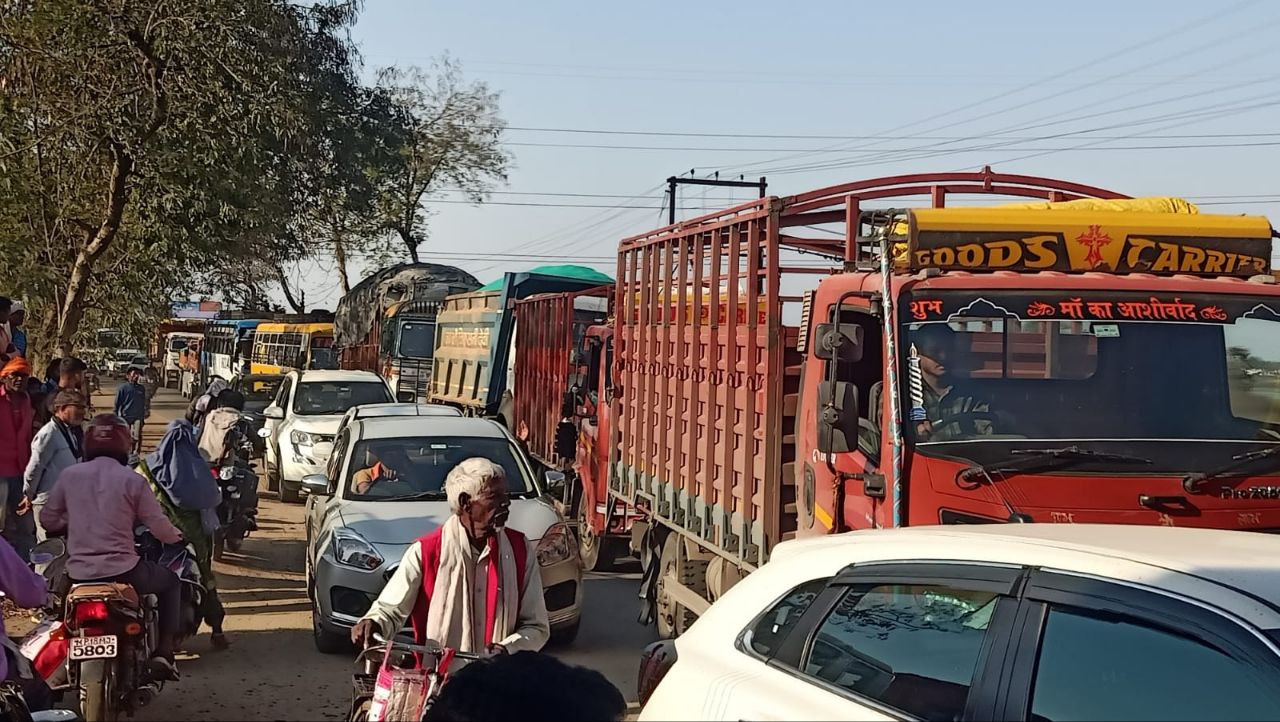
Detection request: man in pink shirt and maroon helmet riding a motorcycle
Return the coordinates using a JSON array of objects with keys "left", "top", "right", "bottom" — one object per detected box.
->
[{"left": 40, "top": 413, "right": 182, "bottom": 680}]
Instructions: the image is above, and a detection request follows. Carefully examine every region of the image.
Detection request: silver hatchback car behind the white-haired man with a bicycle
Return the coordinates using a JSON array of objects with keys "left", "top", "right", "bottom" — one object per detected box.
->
[{"left": 302, "top": 416, "right": 582, "bottom": 653}]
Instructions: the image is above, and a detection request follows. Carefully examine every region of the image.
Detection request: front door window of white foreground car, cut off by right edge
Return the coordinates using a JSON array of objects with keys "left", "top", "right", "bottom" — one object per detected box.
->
[{"left": 1032, "top": 607, "right": 1280, "bottom": 722}]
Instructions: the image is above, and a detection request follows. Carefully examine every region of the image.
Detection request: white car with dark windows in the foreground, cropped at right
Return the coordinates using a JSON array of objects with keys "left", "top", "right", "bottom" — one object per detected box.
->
[{"left": 640, "top": 524, "right": 1280, "bottom": 722}]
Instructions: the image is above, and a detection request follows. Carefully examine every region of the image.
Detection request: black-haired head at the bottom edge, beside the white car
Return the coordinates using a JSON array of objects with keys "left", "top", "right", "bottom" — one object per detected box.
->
[{"left": 424, "top": 652, "right": 627, "bottom": 722}]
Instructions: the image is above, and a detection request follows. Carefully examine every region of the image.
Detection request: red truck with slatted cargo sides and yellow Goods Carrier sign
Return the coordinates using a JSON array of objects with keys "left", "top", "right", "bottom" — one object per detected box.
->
[{"left": 572, "top": 169, "right": 1280, "bottom": 636}]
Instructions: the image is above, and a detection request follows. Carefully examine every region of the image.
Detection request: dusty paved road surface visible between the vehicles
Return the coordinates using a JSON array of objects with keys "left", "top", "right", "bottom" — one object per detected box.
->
[{"left": 95, "top": 388, "right": 654, "bottom": 721}]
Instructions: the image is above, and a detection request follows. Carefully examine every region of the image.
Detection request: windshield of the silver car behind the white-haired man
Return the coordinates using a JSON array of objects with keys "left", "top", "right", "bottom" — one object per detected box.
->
[{"left": 344, "top": 437, "right": 534, "bottom": 501}]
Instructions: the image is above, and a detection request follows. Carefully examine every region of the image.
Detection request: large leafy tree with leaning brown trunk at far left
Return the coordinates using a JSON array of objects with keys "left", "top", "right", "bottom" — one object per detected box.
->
[{"left": 0, "top": 0, "right": 364, "bottom": 355}]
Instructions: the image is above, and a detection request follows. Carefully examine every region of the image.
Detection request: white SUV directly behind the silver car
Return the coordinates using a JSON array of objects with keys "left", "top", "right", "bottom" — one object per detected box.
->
[{"left": 261, "top": 371, "right": 392, "bottom": 503}]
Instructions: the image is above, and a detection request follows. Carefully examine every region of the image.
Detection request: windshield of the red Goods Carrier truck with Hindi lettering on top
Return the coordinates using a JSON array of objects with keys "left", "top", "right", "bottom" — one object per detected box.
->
[{"left": 902, "top": 292, "right": 1280, "bottom": 445}]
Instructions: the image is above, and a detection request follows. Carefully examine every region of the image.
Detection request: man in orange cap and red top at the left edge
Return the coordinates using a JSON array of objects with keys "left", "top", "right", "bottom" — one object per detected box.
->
[{"left": 0, "top": 356, "right": 36, "bottom": 559}]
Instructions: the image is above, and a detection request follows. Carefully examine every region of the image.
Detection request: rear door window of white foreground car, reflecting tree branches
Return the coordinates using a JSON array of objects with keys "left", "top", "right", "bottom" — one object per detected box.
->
[{"left": 804, "top": 584, "right": 998, "bottom": 722}]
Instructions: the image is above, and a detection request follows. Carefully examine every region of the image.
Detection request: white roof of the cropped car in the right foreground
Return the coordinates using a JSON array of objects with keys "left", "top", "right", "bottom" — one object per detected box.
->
[{"left": 765, "top": 524, "right": 1280, "bottom": 627}]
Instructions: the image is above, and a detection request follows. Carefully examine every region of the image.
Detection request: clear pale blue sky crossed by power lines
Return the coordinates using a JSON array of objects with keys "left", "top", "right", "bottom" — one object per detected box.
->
[{"left": 275, "top": 0, "right": 1280, "bottom": 309}]
